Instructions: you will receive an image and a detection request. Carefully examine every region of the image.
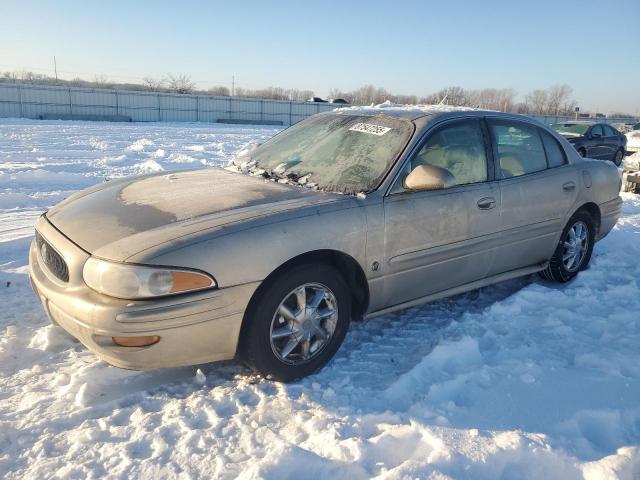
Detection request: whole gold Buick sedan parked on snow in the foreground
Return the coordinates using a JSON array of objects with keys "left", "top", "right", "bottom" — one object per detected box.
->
[{"left": 29, "top": 105, "right": 622, "bottom": 381}]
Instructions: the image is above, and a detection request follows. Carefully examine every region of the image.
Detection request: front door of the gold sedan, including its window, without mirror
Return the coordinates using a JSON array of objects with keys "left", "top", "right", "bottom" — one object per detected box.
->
[{"left": 384, "top": 118, "right": 500, "bottom": 305}]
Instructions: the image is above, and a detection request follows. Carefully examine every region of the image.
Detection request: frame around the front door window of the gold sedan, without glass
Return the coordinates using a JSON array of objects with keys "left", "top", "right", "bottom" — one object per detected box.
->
[{"left": 387, "top": 116, "right": 496, "bottom": 195}]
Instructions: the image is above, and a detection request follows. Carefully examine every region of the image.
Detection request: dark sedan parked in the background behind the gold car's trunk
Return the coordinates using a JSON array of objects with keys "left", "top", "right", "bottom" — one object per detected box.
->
[{"left": 552, "top": 121, "right": 627, "bottom": 167}]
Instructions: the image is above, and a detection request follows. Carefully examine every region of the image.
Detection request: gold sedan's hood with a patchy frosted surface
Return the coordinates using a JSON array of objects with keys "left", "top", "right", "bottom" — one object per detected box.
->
[{"left": 46, "top": 168, "right": 344, "bottom": 261}]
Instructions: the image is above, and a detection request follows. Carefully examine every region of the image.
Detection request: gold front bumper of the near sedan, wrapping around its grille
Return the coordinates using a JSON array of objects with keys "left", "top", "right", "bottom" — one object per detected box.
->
[{"left": 29, "top": 216, "right": 259, "bottom": 370}]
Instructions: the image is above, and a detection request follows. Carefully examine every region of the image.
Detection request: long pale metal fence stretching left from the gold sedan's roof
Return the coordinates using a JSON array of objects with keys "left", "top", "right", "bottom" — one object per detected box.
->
[{"left": 0, "top": 83, "right": 340, "bottom": 125}]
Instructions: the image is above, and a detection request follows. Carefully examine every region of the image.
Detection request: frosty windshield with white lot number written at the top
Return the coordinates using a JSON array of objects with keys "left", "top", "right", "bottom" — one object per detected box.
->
[{"left": 250, "top": 113, "right": 413, "bottom": 193}]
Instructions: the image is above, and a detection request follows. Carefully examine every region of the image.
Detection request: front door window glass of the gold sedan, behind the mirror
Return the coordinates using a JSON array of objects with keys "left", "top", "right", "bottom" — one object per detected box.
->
[{"left": 411, "top": 120, "right": 487, "bottom": 185}]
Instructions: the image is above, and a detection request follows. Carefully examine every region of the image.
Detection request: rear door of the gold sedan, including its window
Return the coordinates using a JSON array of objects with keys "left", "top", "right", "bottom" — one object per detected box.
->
[{"left": 487, "top": 118, "right": 578, "bottom": 275}]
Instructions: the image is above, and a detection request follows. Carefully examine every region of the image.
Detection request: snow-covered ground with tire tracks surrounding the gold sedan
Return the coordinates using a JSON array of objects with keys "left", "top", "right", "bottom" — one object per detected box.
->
[{"left": 0, "top": 119, "right": 640, "bottom": 479}]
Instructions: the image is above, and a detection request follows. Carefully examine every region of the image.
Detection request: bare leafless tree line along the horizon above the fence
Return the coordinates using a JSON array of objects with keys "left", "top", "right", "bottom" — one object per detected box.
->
[{"left": 0, "top": 71, "right": 633, "bottom": 118}]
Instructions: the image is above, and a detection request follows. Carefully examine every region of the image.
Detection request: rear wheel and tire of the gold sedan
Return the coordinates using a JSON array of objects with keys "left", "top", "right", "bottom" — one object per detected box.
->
[{"left": 540, "top": 210, "right": 595, "bottom": 283}]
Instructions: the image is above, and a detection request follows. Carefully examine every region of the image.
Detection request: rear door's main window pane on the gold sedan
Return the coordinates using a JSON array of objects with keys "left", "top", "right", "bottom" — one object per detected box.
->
[{"left": 490, "top": 121, "right": 547, "bottom": 178}]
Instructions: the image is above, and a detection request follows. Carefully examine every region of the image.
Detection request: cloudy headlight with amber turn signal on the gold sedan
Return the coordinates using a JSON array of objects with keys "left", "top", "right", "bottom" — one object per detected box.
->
[{"left": 82, "top": 257, "right": 216, "bottom": 299}]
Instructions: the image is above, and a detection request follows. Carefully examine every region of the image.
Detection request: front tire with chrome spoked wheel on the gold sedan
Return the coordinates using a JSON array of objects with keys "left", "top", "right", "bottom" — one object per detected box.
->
[{"left": 239, "top": 264, "right": 351, "bottom": 382}]
